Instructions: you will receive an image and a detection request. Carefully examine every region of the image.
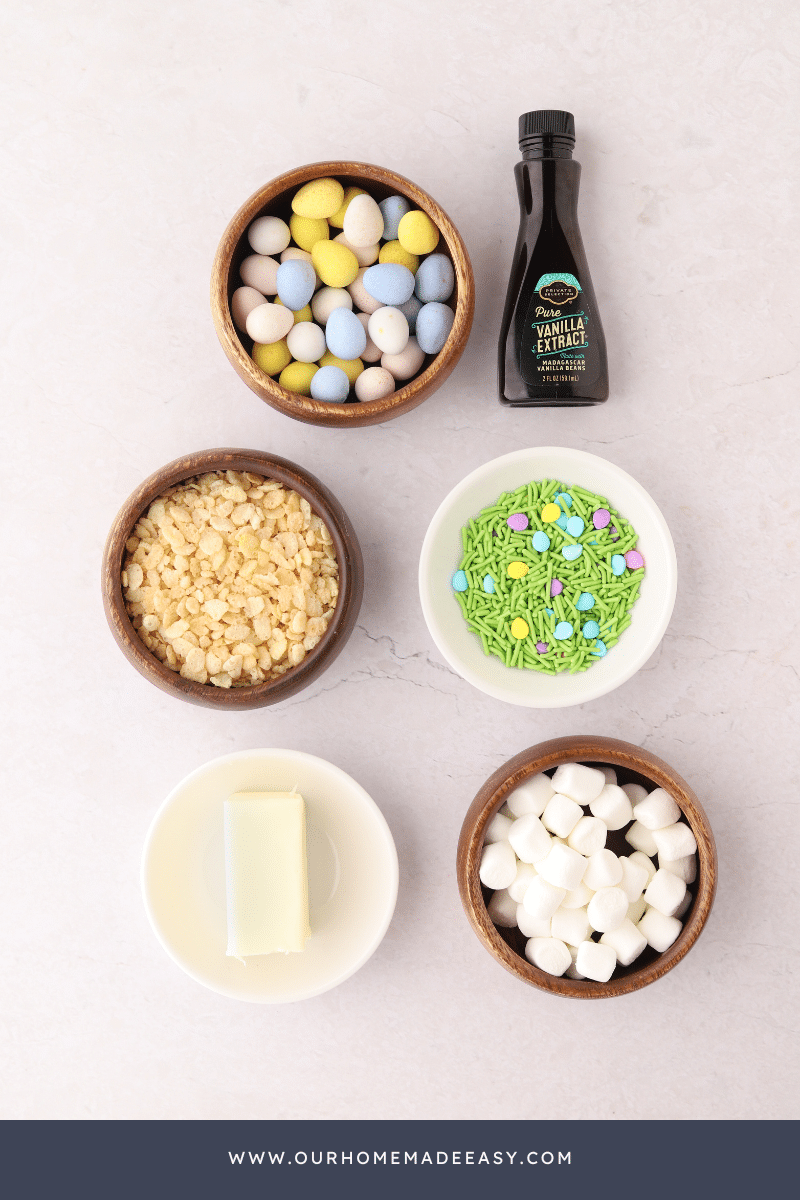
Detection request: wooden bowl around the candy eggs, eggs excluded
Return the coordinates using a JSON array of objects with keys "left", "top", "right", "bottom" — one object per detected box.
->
[{"left": 211, "top": 162, "right": 475, "bottom": 428}]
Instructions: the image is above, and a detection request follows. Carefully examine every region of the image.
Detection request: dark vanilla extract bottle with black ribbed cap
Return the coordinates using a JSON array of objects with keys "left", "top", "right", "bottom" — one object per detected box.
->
[{"left": 498, "top": 109, "right": 608, "bottom": 408}]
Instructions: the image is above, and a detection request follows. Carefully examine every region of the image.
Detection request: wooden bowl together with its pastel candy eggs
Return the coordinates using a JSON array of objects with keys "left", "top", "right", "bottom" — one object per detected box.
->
[{"left": 211, "top": 161, "right": 475, "bottom": 427}]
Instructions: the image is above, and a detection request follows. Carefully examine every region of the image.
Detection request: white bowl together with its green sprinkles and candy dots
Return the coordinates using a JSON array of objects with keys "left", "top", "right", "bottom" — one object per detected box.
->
[{"left": 420, "top": 446, "right": 678, "bottom": 708}]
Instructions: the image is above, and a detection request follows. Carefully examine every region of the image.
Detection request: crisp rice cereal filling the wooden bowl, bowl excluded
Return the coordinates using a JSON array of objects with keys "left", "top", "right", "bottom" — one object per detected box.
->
[{"left": 122, "top": 470, "right": 338, "bottom": 688}]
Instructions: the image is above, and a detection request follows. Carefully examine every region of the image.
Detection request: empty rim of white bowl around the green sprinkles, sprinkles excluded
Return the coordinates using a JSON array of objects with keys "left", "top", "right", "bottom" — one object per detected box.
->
[{"left": 420, "top": 446, "right": 678, "bottom": 708}]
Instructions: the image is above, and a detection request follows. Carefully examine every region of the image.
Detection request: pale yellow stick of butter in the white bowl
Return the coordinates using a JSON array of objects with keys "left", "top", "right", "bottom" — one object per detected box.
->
[{"left": 224, "top": 792, "right": 311, "bottom": 959}]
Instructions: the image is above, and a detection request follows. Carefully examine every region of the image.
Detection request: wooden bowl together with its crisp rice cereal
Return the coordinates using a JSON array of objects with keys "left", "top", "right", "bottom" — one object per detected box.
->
[{"left": 102, "top": 449, "right": 363, "bottom": 709}]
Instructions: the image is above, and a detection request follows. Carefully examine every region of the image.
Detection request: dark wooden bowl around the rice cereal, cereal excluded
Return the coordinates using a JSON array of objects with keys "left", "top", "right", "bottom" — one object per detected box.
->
[{"left": 102, "top": 449, "right": 363, "bottom": 709}]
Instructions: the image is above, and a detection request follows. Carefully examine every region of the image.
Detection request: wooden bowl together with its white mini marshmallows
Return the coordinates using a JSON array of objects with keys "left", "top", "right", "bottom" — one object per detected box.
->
[{"left": 456, "top": 736, "right": 717, "bottom": 1000}]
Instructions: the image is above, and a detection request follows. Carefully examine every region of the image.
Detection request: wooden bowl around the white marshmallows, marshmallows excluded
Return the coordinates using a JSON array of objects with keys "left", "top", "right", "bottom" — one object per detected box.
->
[{"left": 456, "top": 736, "right": 717, "bottom": 1000}]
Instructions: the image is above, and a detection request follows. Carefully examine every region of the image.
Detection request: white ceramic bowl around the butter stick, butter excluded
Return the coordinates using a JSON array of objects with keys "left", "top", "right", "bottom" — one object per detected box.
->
[{"left": 142, "top": 750, "right": 398, "bottom": 1004}]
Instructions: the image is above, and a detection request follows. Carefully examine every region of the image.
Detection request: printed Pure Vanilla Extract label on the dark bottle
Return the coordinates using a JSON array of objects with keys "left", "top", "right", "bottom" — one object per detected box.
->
[{"left": 519, "top": 271, "right": 589, "bottom": 385}]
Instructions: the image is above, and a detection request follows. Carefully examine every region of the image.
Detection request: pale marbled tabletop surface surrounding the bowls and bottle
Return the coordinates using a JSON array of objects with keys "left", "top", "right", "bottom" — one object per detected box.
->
[{"left": 0, "top": 0, "right": 800, "bottom": 1118}]
